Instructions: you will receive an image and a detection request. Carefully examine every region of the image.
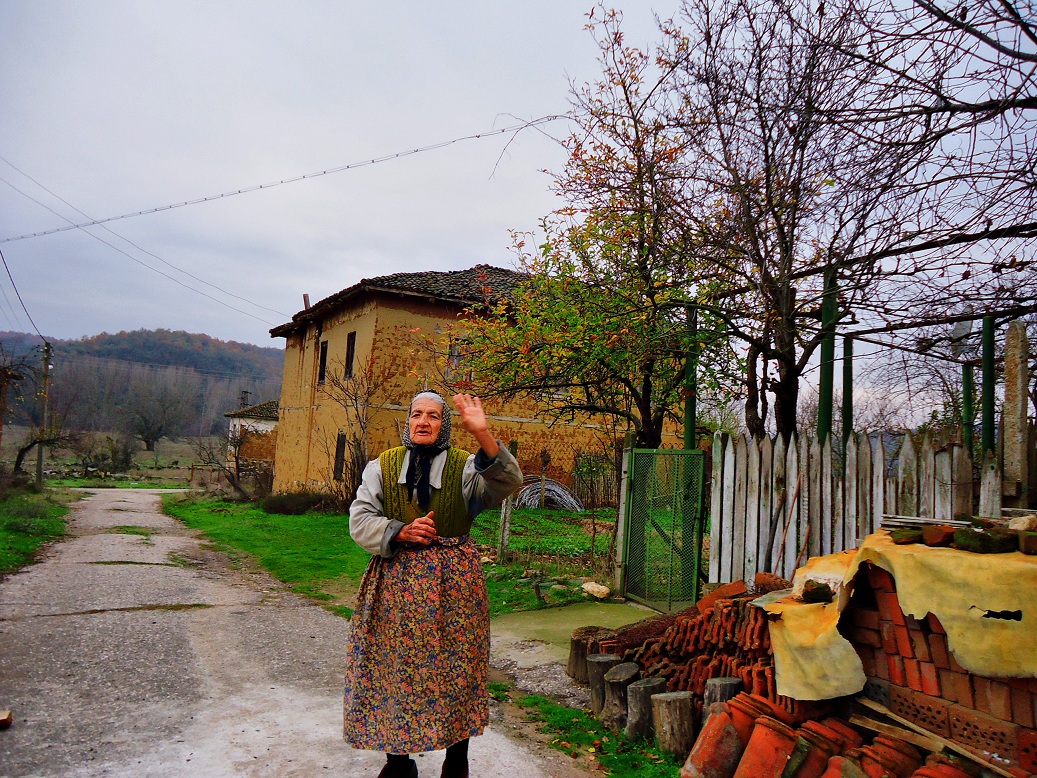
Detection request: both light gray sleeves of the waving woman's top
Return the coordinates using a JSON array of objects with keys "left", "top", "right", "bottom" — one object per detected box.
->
[{"left": 349, "top": 441, "right": 522, "bottom": 558}]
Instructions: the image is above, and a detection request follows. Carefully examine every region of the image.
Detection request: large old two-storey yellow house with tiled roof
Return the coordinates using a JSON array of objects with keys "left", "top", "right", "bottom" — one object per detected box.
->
[{"left": 271, "top": 265, "right": 615, "bottom": 493}]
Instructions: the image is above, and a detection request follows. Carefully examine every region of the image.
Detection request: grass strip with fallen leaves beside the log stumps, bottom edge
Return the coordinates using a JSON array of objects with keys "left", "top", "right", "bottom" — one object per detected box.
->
[{"left": 508, "top": 685, "right": 680, "bottom": 778}]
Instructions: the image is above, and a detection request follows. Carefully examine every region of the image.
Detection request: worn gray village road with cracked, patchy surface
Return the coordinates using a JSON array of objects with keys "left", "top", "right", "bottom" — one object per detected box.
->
[{"left": 0, "top": 490, "right": 587, "bottom": 778}]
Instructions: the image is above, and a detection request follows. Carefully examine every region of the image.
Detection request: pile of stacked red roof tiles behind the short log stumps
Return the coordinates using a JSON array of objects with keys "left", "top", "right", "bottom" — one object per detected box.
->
[{"left": 622, "top": 581, "right": 825, "bottom": 726}]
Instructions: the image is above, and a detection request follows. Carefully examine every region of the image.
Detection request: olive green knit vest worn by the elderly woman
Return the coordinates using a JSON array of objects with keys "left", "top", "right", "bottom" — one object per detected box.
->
[{"left": 379, "top": 446, "right": 472, "bottom": 537}]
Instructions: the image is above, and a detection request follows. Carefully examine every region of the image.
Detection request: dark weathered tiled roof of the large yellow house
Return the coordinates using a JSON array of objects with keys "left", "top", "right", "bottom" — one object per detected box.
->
[{"left": 270, "top": 265, "right": 526, "bottom": 337}]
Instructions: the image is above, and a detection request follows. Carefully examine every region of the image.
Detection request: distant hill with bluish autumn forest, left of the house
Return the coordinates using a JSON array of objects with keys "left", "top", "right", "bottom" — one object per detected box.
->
[{"left": 0, "top": 330, "right": 284, "bottom": 382}]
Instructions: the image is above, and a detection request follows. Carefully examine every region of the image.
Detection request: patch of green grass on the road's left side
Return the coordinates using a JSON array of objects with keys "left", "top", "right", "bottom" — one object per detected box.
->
[{"left": 0, "top": 489, "right": 68, "bottom": 576}]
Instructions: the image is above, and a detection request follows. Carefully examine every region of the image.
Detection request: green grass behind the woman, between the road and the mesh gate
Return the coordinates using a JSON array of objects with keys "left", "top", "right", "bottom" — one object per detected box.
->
[{"left": 165, "top": 495, "right": 609, "bottom": 616}]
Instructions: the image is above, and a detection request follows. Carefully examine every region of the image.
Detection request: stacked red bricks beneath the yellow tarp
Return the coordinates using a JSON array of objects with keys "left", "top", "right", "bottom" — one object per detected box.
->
[{"left": 839, "top": 564, "right": 1037, "bottom": 773}]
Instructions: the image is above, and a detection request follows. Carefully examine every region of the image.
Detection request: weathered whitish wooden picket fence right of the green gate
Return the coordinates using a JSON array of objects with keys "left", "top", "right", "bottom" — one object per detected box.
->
[{"left": 709, "top": 434, "right": 983, "bottom": 583}]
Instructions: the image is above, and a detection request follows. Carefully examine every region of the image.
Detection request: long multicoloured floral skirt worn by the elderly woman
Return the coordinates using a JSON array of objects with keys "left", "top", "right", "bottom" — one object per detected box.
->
[{"left": 342, "top": 535, "right": 489, "bottom": 754}]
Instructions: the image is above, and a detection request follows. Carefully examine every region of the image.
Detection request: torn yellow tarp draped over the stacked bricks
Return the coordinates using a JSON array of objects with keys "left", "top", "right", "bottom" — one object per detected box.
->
[{"left": 760, "top": 531, "right": 1037, "bottom": 700}]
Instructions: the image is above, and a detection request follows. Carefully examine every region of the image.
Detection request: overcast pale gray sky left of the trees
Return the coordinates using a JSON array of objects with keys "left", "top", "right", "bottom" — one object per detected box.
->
[{"left": 0, "top": 0, "right": 677, "bottom": 346}]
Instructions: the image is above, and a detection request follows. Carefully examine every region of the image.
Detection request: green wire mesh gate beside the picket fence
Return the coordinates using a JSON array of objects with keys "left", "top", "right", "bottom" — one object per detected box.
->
[{"left": 623, "top": 448, "right": 705, "bottom": 612}]
